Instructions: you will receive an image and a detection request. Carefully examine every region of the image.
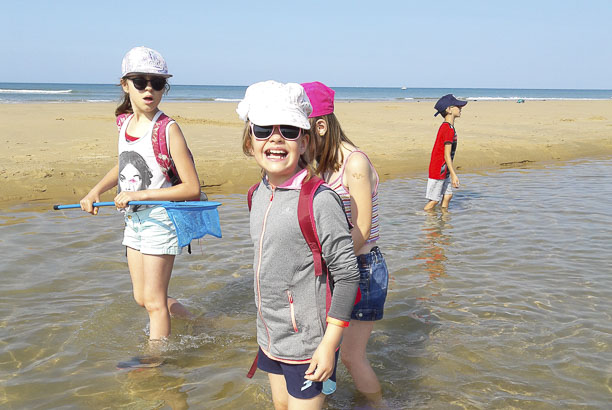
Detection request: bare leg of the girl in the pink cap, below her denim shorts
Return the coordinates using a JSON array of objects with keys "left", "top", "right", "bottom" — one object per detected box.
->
[{"left": 340, "top": 320, "right": 382, "bottom": 403}]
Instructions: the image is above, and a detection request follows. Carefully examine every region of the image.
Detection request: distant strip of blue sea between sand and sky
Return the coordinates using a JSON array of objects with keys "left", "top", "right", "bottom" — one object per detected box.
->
[{"left": 0, "top": 83, "right": 612, "bottom": 103}]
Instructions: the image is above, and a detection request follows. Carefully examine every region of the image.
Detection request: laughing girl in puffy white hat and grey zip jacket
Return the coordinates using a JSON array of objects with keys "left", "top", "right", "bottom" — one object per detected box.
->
[{"left": 237, "top": 81, "right": 359, "bottom": 409}]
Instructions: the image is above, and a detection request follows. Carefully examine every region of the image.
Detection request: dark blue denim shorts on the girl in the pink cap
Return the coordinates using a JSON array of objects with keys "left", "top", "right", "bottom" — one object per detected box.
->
[{"left": 351, "top": 246, "right": 389, "bottom": 321}]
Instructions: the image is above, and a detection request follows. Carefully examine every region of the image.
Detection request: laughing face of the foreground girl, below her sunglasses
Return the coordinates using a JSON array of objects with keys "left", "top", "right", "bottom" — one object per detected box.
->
[{"left": 251, "top": 121, "right": 309, "bottom": 186}]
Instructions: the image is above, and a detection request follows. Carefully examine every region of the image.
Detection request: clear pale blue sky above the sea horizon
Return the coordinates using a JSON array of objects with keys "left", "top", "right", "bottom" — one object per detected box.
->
[{"left": 0, "top": 0, "right": 612, "bottom": 89}]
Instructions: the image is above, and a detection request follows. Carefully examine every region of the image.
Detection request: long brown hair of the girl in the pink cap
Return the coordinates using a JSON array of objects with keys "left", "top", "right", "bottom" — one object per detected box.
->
[{"left": 310, "top": 112, "right": 355, "bottom": 175}]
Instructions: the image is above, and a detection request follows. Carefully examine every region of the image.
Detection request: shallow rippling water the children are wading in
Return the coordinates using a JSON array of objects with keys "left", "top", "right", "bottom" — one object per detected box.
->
[{"left": 0, "top": 160, "right": 612, "bottom": 409}]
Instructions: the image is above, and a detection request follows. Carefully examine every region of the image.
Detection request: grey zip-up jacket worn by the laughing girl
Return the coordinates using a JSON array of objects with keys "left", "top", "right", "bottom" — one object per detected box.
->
[{"left": 250, "top": 171, "right": 359, "bottom": 363}]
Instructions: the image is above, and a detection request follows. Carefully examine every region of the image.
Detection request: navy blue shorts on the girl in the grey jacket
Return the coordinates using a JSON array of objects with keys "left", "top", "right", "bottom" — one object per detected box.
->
[{"left": 257, "top": 348, "right": 340, "bottom": 399}]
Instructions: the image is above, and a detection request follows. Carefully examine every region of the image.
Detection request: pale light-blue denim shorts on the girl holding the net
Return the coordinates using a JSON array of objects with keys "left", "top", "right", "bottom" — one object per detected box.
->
[{"left": 123, "top": 206, "right": 182, "bottom": 255}]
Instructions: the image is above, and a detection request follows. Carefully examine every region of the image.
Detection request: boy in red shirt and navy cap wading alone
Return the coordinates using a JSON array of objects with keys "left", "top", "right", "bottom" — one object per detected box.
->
[{"left": 423, "top": 94, "right": 467, "bottom": 211}]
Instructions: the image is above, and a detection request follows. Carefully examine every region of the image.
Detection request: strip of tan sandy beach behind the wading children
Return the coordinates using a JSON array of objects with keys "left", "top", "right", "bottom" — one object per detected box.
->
[{"left": 0, "top": 100, "right": 612, "bottom": 208}]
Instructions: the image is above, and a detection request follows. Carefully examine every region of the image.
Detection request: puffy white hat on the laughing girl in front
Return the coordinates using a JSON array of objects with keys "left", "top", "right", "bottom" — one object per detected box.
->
[{"left": 236, "top": 80, "right": 312, "bottom": 130}]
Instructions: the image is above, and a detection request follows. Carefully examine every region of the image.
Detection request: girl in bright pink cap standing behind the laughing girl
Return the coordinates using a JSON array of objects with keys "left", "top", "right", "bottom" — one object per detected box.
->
[{"left": 302, "top": 82, "right": 389, "bottom": 402}]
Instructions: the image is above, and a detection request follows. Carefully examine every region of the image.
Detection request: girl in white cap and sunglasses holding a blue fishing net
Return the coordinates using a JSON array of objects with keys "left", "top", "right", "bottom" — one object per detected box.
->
[{"left": 81, "top": 47, "right": 200, "bottom": 367}]
